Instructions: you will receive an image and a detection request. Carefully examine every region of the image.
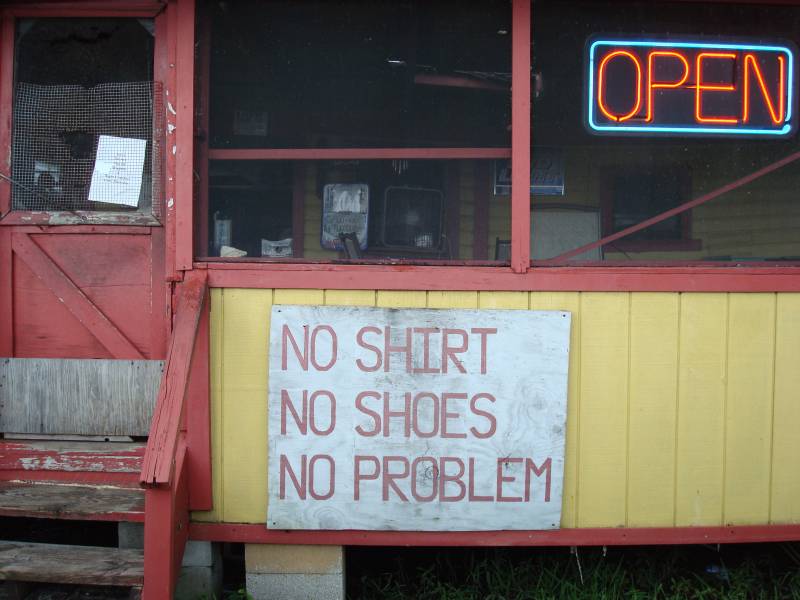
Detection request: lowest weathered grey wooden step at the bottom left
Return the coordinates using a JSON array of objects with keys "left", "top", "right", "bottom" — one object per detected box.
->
[{"left": 0, "top": 541, "right": 144, "bottom": 587}]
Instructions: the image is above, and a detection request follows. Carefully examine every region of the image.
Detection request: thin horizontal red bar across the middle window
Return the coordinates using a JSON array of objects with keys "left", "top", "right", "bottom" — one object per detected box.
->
[{"left": 208, "top": 148, "right": 511, "bottom": 160}]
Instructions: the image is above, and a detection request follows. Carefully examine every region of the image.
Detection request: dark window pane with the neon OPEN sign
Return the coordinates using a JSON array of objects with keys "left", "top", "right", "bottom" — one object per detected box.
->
[{"left": 531, "top": 0, "right": 800, "bottom": 262}]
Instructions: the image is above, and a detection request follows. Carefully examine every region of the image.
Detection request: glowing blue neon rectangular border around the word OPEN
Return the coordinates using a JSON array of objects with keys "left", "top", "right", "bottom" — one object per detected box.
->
[{"left": 587, "top": 39, "right": 795, "bottom": 136}]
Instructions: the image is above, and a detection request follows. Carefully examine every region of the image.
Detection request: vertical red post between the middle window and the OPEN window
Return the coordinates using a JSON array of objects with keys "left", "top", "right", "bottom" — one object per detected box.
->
[{"left": 511, "top": 0, "right": 531, "bottom": 273}]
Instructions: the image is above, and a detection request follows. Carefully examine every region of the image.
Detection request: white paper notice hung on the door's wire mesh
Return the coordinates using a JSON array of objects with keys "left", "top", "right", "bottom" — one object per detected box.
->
[{"left": 89, "top": 135, "right": 147, "bottom": 207}]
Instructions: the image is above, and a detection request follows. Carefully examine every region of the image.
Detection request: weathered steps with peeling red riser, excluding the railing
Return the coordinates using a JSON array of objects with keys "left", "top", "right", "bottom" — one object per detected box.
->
[{"left": 0, "top": 440, "right": 145, "bottom": 597}]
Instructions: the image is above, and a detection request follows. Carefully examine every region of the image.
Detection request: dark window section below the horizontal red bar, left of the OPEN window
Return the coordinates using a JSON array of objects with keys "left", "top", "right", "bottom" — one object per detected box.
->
[{"left": 205, "top": 160, "right": 511, "bottom": 262}]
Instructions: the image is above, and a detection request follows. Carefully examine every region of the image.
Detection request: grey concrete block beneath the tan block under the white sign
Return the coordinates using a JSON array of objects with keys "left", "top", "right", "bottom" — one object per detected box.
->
[{"left": 247, "top": 571, "right": 345, "bottom": 600}]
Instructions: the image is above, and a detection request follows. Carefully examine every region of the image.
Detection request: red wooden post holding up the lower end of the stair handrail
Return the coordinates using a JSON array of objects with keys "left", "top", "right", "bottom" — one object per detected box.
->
[{"left": 142, "top": 440, "right": 189, "bottom": 600}]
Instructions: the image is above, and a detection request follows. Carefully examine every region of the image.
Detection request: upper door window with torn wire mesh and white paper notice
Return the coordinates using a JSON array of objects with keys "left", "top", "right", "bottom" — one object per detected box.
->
[{"left": 11, "top": 18, "right": 163, "bottom": 213}]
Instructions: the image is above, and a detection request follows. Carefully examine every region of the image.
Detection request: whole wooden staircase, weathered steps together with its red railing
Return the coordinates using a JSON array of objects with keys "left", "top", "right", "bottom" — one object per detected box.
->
[{"left": 0, "top": 271, "right": 212, "bottom": 600}]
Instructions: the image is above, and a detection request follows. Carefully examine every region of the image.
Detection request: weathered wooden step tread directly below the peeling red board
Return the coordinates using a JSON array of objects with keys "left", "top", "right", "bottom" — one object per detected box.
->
[{"left": 0, "top": 481, "right": 144, "bottom": 521}]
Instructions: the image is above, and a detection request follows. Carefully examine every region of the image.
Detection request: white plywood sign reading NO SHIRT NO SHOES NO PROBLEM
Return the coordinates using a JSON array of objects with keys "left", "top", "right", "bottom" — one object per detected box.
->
[{"left": 267, "top": 306, "right": 570, "bottom": 531}]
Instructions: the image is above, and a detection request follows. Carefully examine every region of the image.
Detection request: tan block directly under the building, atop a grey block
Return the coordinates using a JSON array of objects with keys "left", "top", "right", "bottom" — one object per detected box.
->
[{"left": 245, "top": 544, "right": 344, "bottom": 575}]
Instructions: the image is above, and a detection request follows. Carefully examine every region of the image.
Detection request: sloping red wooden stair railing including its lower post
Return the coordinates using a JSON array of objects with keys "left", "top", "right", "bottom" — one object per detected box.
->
[{"left": 139, "top": 271, "right": 210, "bottom": 600}]
